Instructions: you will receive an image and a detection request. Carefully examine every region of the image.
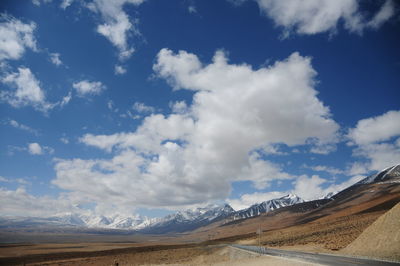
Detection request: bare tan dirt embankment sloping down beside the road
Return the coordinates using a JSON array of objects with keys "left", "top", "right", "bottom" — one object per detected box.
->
[{"left": 343, "top": 203, "right": 400, "bottom": 261}]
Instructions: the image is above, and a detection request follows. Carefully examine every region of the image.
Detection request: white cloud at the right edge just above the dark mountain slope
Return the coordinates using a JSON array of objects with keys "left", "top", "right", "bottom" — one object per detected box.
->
[{"left": 347, "top": 111, "right": 400, "bottom": 174}]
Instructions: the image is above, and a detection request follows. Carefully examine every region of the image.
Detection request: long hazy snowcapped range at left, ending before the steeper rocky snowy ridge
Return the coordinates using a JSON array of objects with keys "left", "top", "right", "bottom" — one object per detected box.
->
[{"left": 0, "top": 205, "right": 234, "bottom": 233}]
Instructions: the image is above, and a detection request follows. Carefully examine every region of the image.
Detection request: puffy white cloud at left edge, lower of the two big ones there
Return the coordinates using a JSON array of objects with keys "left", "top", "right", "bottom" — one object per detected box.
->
[{"left": 0, "top": 67, "right": 54, "bottom": 112}]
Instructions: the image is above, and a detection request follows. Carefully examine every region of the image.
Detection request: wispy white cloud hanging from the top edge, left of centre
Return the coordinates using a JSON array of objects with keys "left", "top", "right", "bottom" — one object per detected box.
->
[{"left": 88, "top": 0, "right": 144, "bottom": 60}]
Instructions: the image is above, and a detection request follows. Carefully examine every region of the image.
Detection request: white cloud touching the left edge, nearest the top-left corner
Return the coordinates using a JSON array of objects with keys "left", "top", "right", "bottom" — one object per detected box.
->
[{"left": 0, "top": 14, "right": 37, "bottom": 62}]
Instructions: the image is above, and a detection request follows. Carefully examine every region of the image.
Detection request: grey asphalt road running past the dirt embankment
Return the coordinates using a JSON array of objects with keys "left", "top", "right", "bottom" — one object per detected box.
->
[{"left": 231, "top": 245, "right": 400, "bottom": 266}]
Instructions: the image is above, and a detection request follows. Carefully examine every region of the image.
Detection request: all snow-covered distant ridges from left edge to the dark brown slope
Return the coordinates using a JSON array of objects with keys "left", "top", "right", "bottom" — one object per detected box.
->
[{"left": 0, "top": 194, "right": 304, "bottom": 234}]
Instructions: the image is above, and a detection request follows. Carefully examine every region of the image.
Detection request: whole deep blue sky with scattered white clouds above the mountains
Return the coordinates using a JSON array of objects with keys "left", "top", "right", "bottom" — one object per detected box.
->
[{"left": 0, "top": 0, "right": 400, "bottom": 217}]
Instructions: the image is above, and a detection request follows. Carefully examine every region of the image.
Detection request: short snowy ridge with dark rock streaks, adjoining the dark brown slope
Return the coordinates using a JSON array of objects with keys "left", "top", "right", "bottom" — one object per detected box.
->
[{"left": 233, "top": 194, "right": 304, "bottom": 220}]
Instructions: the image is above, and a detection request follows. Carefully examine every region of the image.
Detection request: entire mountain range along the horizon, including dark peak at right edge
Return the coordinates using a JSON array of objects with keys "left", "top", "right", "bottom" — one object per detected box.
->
[{"left": 0, "top": 165, "right": 400, "bottom": 234}]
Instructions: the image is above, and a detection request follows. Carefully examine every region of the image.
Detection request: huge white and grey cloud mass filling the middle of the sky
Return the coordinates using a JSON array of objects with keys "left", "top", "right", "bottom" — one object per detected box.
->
[{"left": 53, "top": 49, "right": 339, "bottom": 210}]
